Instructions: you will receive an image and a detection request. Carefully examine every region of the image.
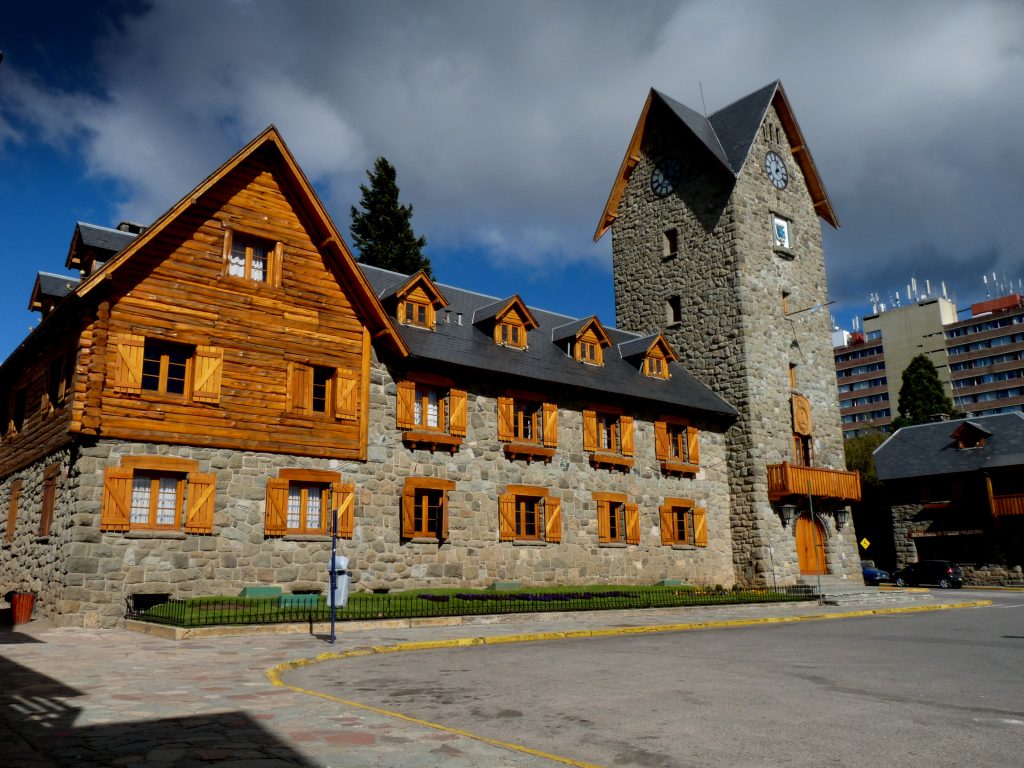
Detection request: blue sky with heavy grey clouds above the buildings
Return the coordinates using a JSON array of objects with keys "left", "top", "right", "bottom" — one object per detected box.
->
[{"left": 0, "top": 0, "right": 1024, "bottom": 356}]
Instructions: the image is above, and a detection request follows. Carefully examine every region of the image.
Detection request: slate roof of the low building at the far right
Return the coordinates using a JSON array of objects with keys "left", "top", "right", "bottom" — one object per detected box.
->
[{"left": 874, "top": 413, "right": 1024, "bottom": 480}]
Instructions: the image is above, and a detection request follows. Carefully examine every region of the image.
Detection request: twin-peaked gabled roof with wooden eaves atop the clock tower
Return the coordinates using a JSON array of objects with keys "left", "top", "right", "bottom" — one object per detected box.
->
[{"left": 594, "top": 80, "right": 839, "bottom": 241}]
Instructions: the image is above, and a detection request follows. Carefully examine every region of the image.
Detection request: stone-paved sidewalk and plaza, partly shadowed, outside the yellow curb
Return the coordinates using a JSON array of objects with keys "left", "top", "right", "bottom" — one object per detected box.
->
[{"left": 0, "top": 595, "right": 991, "bottom": 768}]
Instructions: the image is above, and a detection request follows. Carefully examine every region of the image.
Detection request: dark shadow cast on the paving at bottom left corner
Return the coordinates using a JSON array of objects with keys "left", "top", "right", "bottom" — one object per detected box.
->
[{"left": 0, "top": 657, "right": 314, "bottom": 768}]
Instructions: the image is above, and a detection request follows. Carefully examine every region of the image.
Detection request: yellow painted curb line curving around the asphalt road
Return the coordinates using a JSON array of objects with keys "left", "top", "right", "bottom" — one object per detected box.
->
[{"left": 266, "top": 600, "right": 992, "bottom": 768}]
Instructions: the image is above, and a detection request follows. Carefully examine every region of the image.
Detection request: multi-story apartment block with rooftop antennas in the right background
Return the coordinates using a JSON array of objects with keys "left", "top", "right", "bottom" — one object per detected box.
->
[{"left": 833, "top": 294, "right": 1024, "bottom": 438}]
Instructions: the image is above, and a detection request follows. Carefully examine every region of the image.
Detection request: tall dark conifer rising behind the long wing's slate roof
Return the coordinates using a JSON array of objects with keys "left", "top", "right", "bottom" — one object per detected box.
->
[{"left": 349, "top": 158, "right": 433, "bottom": 278}]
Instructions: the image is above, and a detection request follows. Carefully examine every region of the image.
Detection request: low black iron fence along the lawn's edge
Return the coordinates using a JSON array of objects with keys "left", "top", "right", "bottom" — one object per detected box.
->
[{"left": 125, "top": 586, "right": 814, "bottom": 628}]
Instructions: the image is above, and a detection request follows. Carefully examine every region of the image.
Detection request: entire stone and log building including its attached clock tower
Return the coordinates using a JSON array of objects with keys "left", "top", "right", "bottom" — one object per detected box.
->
[{"left": 0, "top": 85, "right": 856, "bottom": 626}]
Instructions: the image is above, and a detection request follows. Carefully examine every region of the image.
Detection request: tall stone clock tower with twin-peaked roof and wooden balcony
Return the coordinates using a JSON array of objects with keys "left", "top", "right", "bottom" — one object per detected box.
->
[{"left": 595, "top": 82, "right": 860, "bottom": 586}]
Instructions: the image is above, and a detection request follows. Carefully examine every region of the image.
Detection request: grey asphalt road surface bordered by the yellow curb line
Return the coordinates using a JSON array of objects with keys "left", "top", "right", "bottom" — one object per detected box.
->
[{"left": 286, "top": 590, "right": 1024, "bottom": 768}]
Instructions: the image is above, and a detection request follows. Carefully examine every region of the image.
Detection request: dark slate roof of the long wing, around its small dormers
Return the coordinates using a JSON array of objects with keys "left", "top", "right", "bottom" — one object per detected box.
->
[{"left": 359, "top": 264, "right": 736, "bottom": 420}]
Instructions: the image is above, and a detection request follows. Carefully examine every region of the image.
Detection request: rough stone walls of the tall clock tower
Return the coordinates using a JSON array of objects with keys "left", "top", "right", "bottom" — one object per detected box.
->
[{"left": 612, "top": 100, "right": 860, "bottom": 584}]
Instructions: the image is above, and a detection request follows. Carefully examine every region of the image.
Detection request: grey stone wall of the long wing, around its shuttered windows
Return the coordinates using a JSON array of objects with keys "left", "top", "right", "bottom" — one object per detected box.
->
[{"left": 0, "top": 361, "right": 733, "bottom": 627}]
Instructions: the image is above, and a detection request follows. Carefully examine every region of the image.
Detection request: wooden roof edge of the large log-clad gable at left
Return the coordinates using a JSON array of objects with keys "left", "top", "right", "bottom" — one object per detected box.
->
[{"left": 75, "top": 125, "right": 409, "bottom": 354}]
